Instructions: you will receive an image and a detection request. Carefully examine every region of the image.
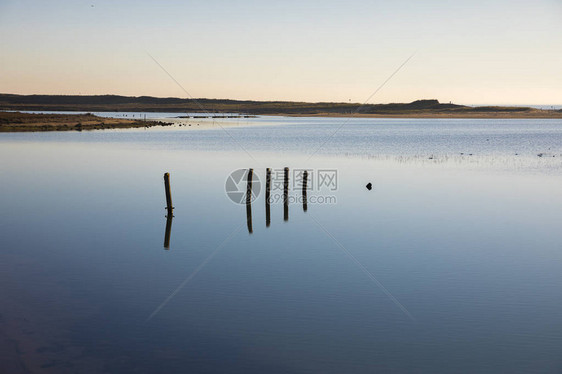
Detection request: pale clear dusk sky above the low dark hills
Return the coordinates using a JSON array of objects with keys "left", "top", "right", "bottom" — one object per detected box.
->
[{"left": 0, "top": 0, "right": 562, "bottom": 105}]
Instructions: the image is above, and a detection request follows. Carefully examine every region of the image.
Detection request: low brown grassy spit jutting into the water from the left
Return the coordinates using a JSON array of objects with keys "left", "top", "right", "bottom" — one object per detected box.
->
[{"left": 0, "top": 112, "right": 171, "bottom": 132}]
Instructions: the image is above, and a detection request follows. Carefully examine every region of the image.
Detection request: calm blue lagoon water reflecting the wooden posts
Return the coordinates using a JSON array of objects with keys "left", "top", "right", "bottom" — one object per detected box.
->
[{"left": 0, "top": 114, "right": 562, "bottom": 373}]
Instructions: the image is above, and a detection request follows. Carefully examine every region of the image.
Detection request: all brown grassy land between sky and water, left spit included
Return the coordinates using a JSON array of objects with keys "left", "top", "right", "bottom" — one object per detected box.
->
[{"left": 0, "top": 94, "right": 562, "bottom": 132}]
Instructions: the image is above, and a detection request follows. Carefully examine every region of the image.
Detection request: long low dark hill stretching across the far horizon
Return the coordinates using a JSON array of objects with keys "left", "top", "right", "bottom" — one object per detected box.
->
[{"left": 0, "top": 94, "right": 559, "bottom": 116}]
